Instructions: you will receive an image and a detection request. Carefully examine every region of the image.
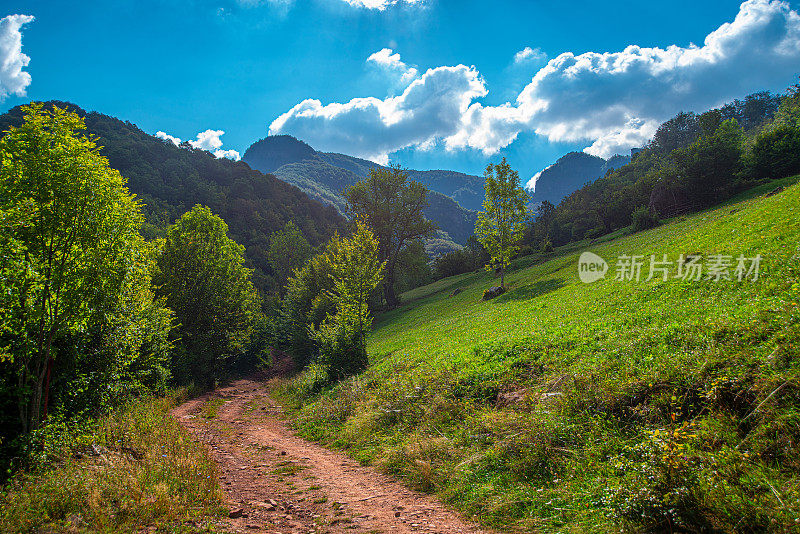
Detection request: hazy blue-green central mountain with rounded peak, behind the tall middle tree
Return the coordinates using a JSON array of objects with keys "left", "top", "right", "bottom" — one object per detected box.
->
[{"left": 242, "top": 135, "right": 483, "bottom": 248}]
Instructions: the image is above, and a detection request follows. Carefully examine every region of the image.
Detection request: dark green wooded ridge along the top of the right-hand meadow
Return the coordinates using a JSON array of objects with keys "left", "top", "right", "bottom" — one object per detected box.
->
[{"left": 524, "top": 89, "right": 800, "bottom": 248}]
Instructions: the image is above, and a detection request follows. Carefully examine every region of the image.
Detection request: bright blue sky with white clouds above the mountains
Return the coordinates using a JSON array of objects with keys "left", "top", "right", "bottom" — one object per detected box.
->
[{"left": 0, "top": 0, "right": 800, "bottom": 188}]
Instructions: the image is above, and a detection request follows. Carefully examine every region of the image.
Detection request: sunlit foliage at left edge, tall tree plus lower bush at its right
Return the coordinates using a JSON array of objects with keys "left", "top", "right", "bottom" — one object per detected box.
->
[{"left": 0, "top": 104, "right": 169, "bottom": 432}]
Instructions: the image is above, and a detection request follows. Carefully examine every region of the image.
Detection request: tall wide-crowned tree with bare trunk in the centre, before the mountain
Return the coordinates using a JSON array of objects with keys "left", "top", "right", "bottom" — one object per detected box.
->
[{"left": 345, "top": 166, "right": 436, "bottom": 307}]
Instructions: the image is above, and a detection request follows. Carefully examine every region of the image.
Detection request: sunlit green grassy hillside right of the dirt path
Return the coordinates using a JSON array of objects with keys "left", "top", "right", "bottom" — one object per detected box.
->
[{"left": 281, "top": 177, "right": 800, "bottom": 532}]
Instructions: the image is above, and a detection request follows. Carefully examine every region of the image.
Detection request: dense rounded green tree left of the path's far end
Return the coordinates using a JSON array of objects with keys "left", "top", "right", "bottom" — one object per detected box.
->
[{"left": 154, "top": 206, "right": 259, "bottom": 386}]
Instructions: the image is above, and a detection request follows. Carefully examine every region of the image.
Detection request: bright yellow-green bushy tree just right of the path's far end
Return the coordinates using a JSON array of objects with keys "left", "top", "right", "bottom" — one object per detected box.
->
[{"left": 314, "top": 221, "right": 385, "bottom": 378}]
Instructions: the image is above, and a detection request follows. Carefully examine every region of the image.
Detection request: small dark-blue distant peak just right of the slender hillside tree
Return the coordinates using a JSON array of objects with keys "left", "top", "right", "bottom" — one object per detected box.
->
[{"left": 531, "top": 152, "right": 631, "bottom": 209}]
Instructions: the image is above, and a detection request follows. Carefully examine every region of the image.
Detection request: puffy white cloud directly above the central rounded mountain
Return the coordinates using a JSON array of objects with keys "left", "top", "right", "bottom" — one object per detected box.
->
[{"left": 269, "top": 65, "right": 486, "bottom": 162}]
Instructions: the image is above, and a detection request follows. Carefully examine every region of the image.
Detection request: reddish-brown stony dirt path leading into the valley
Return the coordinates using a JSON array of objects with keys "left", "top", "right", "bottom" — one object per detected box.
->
[{"left": 173, "top": 380, "right": 486, "bottom": 534}]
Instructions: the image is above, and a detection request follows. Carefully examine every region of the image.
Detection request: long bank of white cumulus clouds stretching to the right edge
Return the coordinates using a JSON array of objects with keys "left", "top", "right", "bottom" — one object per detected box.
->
[{"left": 270, "top": 0, "right": 800, "bottom": 161}]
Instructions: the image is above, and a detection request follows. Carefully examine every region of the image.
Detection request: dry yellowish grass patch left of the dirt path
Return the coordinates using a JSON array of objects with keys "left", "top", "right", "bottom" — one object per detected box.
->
[{"left": 0, "top": 397, "right": 224, "bottom": 533}]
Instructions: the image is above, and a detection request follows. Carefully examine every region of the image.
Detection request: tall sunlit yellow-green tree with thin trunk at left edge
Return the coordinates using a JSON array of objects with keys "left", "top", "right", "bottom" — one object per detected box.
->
[{"left": 0, "top": 104, "right": 147, "bottom": 432}]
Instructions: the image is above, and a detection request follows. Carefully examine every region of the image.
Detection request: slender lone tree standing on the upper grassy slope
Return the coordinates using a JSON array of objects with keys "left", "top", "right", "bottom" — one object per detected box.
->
[{"left": 475, "top": 158, "right": 528, "bottom": 289}]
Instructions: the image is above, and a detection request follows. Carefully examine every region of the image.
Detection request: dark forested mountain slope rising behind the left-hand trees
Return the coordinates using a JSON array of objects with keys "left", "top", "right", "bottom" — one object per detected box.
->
[{"left": 0, "top": 101, "right": 346, "bottom": 298}]
